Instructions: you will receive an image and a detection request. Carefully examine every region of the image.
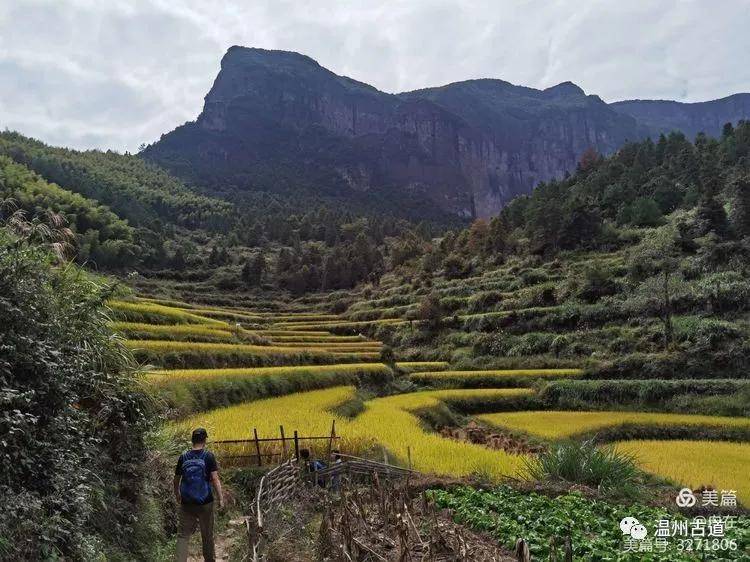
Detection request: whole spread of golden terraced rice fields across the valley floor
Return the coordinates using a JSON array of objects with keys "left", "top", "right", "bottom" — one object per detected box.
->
[{"left": 110, "top": 294, "right": 750, "bottom": 490}]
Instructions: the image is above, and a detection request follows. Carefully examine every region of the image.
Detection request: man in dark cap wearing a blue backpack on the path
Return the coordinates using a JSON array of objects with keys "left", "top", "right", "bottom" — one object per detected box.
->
[{"left": 174, "top": 427, "right": 224, "bottom": 562}]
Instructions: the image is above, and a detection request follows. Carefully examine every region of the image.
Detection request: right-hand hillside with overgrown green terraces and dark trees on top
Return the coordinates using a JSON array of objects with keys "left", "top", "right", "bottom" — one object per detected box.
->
[{"left": 320, "top": 123, "right": 750, "bottom": 388}]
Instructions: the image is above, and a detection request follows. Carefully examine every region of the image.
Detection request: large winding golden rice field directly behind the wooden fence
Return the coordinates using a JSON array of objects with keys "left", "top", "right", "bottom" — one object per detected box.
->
[{"left": 174, "top": 387, "right": 522, "bottom": 478}]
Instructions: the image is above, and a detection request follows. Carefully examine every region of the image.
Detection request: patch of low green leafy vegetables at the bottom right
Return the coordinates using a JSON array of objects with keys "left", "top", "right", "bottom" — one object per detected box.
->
[{"left": 428, "top": 486, "right": 750, "bottom": 561}]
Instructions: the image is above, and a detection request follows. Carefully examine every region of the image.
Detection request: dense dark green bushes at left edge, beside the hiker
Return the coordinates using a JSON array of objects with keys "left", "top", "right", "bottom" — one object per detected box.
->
[{"left": 0, "top": 223, "right": 158, "bottom": 560}]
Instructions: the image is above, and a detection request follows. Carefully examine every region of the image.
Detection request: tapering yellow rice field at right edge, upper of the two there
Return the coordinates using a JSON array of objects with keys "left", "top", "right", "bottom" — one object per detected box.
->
[{"left": 479, "top": 410, "right": 750, "bottom": 439}]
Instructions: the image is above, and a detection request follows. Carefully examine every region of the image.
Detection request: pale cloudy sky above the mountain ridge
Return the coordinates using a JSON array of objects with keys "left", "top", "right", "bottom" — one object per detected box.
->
[{"left": 0, "top": 0, "right": 750, "bottom": 152}]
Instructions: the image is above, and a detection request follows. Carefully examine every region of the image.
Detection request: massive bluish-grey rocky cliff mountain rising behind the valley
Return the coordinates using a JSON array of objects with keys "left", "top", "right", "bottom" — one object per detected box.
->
[{"left": 143, "top": 47, "right": 748, "bottom": 217}]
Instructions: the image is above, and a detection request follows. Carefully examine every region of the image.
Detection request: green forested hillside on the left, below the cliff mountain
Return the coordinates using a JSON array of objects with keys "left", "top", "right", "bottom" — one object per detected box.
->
[{"left": 0, "top": 132, "right": 450, "bottom": 284}]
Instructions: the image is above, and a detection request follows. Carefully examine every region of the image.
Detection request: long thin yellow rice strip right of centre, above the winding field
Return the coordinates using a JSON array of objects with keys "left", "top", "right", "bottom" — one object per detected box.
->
[{"left": 409, "top": 369, "right": 583, "bottom": 388}]
